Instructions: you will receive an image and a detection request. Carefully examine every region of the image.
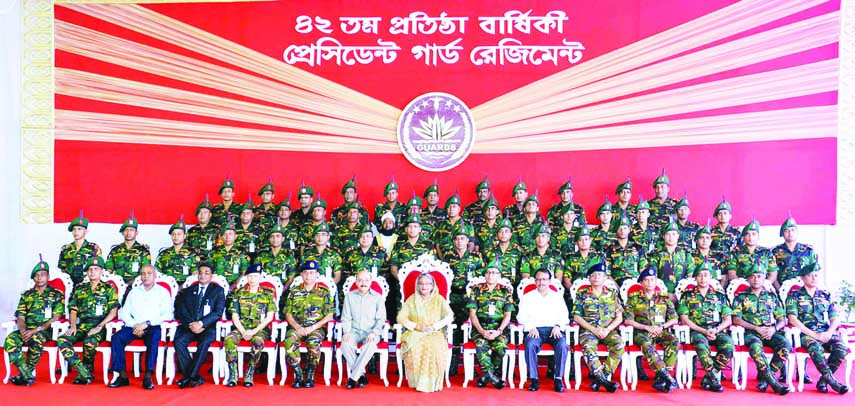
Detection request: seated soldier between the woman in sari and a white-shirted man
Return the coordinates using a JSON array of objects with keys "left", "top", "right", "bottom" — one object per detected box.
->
[{"left": 466, "top": 261, "right": 514, "bottom": 389}]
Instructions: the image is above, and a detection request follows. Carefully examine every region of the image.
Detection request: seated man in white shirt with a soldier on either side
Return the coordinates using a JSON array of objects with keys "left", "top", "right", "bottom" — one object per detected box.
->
[{"left": 517, "top": 268, "right": 570, "bottom": 392}]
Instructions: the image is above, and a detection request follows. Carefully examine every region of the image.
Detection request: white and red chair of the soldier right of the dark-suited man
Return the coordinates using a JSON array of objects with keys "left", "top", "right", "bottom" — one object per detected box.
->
[{"left": 217, "top": 274, "right": 285, "bottom": 386}]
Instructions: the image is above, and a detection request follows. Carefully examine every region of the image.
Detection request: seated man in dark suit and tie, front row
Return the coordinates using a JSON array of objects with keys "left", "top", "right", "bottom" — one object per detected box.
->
[{"left": 174, "top": 262, "right": 226, "bottom": 389}]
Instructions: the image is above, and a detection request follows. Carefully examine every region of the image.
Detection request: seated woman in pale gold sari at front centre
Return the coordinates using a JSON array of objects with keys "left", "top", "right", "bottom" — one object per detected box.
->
[{"left": 398, "top": 273, "right": 454, "bottom": 392}]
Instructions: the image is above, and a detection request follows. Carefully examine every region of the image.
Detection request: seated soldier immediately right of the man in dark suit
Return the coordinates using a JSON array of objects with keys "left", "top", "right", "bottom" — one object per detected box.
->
[{"left": 223, "top": 264, "right": 277, "bottom": 388}]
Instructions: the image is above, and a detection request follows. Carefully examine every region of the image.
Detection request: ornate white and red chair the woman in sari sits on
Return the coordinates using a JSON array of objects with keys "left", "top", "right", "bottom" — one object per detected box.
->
[{"left": 393, "top": 254, "right": 455, "bottom": 388}]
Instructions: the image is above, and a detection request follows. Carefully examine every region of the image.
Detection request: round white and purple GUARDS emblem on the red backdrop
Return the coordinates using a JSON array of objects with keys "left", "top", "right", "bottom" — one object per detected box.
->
[{"left": 398, "top": 92, "right": 475, "bottom": 172}]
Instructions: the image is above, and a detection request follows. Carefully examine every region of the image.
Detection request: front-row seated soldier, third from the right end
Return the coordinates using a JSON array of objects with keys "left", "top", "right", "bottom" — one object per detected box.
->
[{"left": 677, "top": 264, "right": 733, "bottom": 392}]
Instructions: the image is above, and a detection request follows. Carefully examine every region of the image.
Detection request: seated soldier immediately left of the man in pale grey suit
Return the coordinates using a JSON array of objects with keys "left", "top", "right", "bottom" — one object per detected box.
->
[{"left": 282, "top": 261, "right": 333, "bottom": 388}]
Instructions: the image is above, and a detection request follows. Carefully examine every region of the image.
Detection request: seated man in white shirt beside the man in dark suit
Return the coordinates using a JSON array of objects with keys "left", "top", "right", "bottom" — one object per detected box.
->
[{"left": 107, "top": 265, "right": 172, "bottom": 389}]
